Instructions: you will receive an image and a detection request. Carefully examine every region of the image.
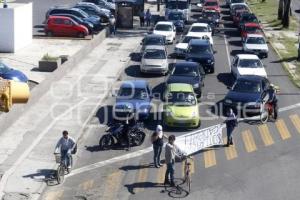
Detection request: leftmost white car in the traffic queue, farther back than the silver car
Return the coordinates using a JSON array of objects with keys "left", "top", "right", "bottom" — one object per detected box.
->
[{"left": 153, "top": 21, "right": 176, "bottom": 44}]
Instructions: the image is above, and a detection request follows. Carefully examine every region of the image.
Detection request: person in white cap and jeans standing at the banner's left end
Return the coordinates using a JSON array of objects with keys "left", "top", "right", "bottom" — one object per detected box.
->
[{"left": 151, "top": 125, "right": 168, "bottom": 168}]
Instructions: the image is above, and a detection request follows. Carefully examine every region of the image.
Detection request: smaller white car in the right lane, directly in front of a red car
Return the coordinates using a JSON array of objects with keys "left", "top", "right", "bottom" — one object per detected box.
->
[{"left": 243, "top": 34, "right": 269, "bottom": 58}]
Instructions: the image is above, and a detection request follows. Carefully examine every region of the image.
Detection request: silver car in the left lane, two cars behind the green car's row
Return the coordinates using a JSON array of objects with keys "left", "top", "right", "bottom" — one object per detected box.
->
[{"left": 140, "top": 45, "right": 169, "bottom": 75}]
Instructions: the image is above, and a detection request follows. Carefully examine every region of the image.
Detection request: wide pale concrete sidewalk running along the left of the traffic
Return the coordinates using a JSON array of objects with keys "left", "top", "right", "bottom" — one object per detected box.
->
[{"left": 0, "top": 4, "right": 162, "bottom": 200}]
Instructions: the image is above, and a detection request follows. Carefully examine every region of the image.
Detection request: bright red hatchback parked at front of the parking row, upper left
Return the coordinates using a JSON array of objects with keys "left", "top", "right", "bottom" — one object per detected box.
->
[{"left": 45, "top": 16, "right": 89, "bottom": 38}]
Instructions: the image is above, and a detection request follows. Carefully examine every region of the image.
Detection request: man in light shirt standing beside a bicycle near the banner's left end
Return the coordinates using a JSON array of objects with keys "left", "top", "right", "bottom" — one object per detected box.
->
[{"left": 164, "top": 135, "right": 178, "bottom": 187}]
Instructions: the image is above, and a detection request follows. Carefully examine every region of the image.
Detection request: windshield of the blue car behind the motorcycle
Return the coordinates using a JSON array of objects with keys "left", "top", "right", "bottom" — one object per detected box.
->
[{"left": 118, "top": 87, "right": 148, "bottom": 99}]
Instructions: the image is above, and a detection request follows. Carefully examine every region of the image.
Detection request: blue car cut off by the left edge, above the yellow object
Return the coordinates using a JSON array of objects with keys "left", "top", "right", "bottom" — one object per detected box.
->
[{"left": 0, "top": 62, "right": 28, "bottom": 83}]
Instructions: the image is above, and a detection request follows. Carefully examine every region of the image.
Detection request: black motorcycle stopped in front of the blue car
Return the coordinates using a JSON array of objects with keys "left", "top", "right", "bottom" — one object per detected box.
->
[{"left": 99, "top": 122, "right": 146, "bottom": 150}]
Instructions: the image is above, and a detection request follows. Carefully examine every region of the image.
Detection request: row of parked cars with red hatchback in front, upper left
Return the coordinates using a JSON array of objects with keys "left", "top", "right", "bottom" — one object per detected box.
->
[{"left": 44, "top": 0, "right": 115, "bottom": 38}]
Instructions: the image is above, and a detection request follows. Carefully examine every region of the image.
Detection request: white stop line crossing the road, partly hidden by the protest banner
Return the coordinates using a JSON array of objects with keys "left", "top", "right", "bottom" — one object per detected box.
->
[{"left": 66, "top": 103, "right": 300, "bottom": 178}]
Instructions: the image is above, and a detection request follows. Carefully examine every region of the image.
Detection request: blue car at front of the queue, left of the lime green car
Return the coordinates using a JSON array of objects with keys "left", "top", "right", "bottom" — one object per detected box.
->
[{"left": 113, "top": 80, "right": 152, "bottom": 121}]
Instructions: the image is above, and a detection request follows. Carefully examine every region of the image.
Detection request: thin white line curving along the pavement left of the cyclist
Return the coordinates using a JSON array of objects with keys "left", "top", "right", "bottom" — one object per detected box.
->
[{"left": 0, "top": 98, "right": 88, "bottom": 199}]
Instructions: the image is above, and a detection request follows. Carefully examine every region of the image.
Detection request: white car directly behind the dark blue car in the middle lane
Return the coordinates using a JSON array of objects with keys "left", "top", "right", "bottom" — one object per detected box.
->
[{"left": 187, "top": 23, "right": 214, "bottom": 45}]
